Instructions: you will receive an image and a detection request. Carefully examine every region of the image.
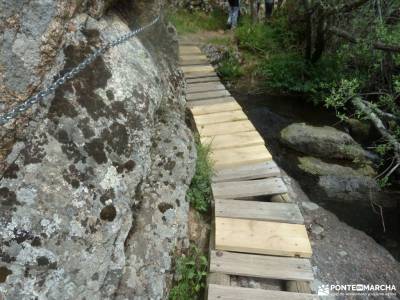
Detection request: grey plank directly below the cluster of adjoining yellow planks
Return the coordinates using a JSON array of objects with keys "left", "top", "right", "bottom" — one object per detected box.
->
[{"left": 212, "top": 161, "right": 281, "bottom": 182}]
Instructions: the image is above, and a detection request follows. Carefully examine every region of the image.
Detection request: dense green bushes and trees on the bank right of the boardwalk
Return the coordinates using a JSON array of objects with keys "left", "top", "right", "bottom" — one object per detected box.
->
[{"left": 168, "top": 0, "right": 400, "bottom": 184}]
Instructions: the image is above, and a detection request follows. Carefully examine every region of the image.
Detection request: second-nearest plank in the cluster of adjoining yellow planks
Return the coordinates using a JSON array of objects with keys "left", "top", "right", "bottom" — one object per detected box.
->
[{"left": 202, "top": 131, "right": 264, "bottom": 150}]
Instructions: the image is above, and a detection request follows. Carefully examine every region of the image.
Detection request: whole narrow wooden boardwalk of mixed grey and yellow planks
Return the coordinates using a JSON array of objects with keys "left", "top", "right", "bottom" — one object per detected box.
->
[{"left": 180, "top": 45, "right": 316, "bottom": 300}]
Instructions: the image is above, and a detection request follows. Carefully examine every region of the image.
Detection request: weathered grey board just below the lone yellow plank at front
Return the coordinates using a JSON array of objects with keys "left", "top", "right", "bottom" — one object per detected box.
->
[{"left": 210, "top": 250, "right": 314, "bottom": 281}]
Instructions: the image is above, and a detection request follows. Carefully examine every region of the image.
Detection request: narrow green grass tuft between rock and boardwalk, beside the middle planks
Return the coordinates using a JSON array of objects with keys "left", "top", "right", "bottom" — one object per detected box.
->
[{"left": 187, "top": 138, "right": 213, "bottom": 213}]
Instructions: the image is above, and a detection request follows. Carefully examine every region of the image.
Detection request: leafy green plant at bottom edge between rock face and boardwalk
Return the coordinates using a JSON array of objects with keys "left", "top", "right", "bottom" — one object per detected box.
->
[{"left": 169, "top": 245, "right": 208, "bottom": 300}]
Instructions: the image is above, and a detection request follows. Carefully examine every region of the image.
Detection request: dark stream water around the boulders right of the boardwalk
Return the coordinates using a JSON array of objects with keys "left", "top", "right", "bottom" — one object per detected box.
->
[{"left": 233, "top": 92, "right": 400, "bottom": 260}]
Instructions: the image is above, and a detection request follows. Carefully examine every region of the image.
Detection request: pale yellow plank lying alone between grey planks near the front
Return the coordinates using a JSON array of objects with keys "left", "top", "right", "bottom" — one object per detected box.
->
[{"left": 215, "top": 217, "right": 312, "bottom": 257}]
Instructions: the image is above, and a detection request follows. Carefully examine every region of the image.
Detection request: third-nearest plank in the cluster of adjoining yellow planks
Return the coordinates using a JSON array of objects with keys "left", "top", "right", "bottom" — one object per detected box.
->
[{"left": 197, "top": 120, "right": 256, "bottom": 137}]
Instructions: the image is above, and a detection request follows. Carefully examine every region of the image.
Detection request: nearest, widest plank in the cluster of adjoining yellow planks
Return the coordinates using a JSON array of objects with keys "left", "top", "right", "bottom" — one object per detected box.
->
[{"left": 210, "top": 145, "right": 272, "bottom": 171}]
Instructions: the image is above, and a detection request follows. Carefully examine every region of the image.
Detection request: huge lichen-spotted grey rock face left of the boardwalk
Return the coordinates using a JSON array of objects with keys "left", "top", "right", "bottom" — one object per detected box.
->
[{"left": 0, "top": 0, "right": 195, "bottom": 299}]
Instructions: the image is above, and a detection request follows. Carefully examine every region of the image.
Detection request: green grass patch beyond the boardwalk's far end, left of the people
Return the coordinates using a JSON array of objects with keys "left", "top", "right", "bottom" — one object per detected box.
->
[{"left": 167, "top": 9, "right": 226, "bottom": 34}]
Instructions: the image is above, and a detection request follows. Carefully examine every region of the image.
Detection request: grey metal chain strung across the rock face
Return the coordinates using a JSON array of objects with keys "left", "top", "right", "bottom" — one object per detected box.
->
[{"left": 0, "top": 16, "right": 160, "bottom": 125}]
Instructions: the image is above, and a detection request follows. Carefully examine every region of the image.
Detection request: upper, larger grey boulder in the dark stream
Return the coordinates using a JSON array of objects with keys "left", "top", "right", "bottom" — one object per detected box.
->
[{"left": 281, "top": 123, "right": 373, "bottom": 161}]
